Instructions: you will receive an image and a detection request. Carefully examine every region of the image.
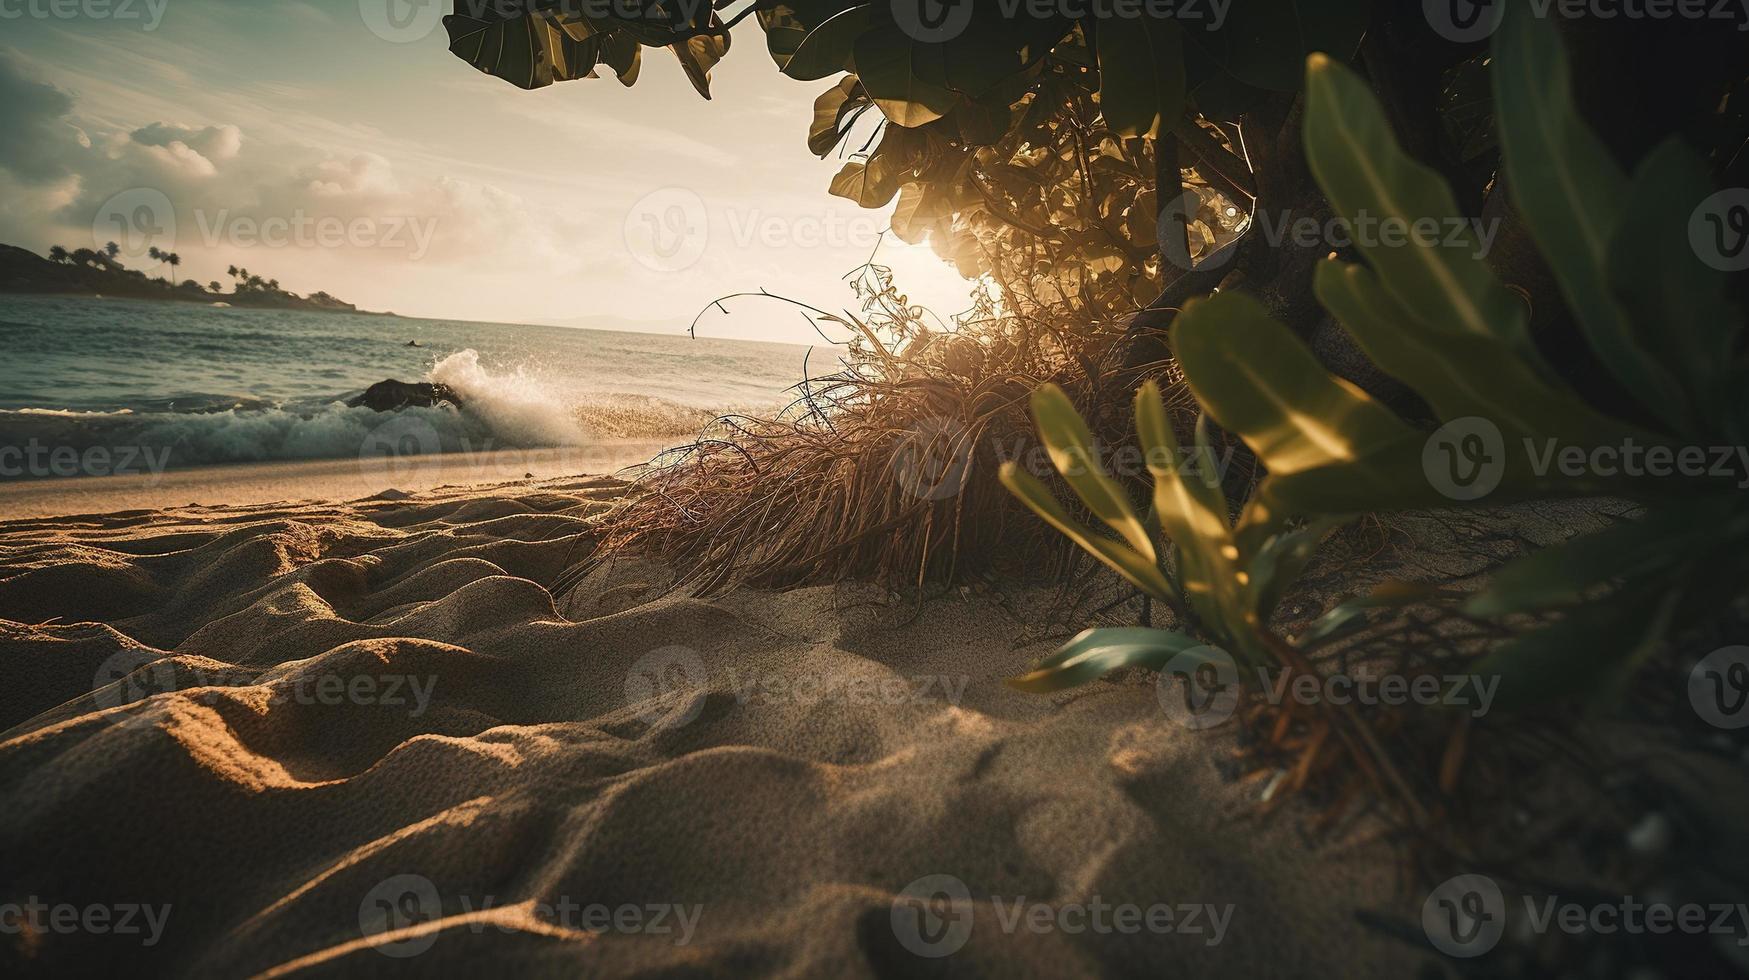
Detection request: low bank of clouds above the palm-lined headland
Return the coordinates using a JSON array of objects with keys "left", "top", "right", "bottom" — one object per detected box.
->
[{"left": 0, "top": 42, "right": 589, "bottom": 296}]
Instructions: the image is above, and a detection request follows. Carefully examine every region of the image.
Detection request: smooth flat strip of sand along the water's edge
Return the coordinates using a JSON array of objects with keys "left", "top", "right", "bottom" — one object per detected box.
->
[{"left": 0, "top": 439, "right": 672, "bottom": 520}]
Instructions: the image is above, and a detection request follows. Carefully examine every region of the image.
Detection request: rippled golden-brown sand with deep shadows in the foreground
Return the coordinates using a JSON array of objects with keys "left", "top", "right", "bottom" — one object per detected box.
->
[{"left": 0, "top": 478, "right": 1420, "bottom": 977}]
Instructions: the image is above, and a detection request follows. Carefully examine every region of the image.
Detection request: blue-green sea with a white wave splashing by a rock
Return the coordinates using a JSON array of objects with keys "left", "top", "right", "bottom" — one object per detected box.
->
[{"left": 0, "top": 296, "right": 836, "bottom": 481}]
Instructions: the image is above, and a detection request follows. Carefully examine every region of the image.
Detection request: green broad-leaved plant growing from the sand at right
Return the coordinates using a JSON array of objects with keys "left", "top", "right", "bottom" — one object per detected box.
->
[{"left": 1013, "top": 7, "right": 1749, "bottom": 705}]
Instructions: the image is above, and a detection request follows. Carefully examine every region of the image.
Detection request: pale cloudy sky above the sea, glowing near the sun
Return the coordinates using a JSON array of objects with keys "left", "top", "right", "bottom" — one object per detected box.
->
[{"left": 0, "top": 0, "right": 971, "bottom": 343}]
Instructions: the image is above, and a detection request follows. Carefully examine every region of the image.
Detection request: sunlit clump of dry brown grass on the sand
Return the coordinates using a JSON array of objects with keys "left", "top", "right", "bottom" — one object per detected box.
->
[{"left": 602, "top": 266, "right": 1193, "bottom": 592}]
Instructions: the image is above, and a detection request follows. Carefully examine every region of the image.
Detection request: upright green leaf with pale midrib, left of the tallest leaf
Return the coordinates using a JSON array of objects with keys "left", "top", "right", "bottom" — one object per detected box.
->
[{"left": 1305, "top": 54, "right": 1537, "bottom": 355}]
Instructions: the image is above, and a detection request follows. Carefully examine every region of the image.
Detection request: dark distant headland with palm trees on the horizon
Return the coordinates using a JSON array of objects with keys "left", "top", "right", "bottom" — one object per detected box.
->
[{"left": 0, "top": 242, "right": 394, "bottom": 317}]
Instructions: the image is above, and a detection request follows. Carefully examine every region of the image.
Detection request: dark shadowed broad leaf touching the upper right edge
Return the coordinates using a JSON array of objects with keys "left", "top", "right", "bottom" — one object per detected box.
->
[{"left": 1607, "top": 138, "right": 1749, "bottom": 443}]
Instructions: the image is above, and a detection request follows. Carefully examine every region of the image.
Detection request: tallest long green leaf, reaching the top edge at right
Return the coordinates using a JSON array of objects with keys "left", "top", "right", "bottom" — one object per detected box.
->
[{"left": 1492, "top": 7, "right": 1691, "bottom": 432}]
